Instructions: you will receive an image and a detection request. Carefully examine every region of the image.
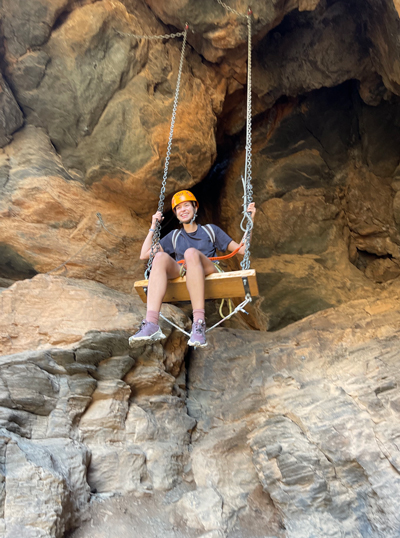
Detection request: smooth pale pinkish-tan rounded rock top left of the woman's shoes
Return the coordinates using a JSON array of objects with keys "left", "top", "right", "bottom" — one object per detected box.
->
[{"left": 0, "top": 275, "right": 187, "bottom": 354}]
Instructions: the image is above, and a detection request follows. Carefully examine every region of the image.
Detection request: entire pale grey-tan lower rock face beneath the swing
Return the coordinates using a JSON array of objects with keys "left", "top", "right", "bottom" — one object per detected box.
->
[{"left": 0, "top": 276, "right": 400, "bottom": 538}]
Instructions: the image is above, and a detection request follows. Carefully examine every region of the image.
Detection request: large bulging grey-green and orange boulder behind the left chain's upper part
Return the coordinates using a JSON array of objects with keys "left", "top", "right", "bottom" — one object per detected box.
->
[{"left": 4, "top": 0, "right": 222, "bottom": 214}]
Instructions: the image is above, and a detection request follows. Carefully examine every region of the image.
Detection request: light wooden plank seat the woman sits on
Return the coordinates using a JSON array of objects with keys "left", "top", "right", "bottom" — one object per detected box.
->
[{"left": 134, "top": 269, "right": 258, "bottom": 303}]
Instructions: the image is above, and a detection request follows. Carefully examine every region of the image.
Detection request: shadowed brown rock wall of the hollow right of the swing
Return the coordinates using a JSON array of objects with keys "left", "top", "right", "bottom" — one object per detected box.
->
[{"left": 219, "top": 83, "right": 400, "bottom": 329}]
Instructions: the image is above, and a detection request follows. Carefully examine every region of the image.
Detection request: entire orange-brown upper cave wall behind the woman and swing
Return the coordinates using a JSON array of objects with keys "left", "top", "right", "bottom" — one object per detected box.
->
[{"left": 0, "top": 0, "right": 400, "bottom": 322}]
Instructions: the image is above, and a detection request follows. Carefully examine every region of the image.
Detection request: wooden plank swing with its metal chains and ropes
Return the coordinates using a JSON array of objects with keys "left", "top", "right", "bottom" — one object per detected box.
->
[{"left": 134, "top": 5, "right": 258, "bottom": 336}]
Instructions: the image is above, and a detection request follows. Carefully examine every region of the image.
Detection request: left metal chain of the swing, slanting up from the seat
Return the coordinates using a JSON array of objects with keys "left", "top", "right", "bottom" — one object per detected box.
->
[{"left": 144, "top": 24, "right": 189, "bottom": 280}]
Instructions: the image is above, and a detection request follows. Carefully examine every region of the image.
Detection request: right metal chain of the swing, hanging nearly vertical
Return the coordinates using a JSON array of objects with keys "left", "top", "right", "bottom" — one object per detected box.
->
[{"left": 239, "top": 11, "right": 253, "bottom": 269}]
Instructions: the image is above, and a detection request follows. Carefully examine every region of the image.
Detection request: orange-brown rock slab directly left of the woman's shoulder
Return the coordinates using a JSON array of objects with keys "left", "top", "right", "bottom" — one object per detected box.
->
[{"left": 0, "top": 126, "right": 149, "bottom": 291}]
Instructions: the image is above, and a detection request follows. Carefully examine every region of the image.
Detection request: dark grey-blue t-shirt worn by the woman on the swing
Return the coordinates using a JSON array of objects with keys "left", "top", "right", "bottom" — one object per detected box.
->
[{"left": 160, "top": 224, "right": 232, "bottom": 261}]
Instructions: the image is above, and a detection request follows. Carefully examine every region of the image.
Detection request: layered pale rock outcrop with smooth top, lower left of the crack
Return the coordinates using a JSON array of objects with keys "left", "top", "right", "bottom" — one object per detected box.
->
[{"left": 0, "top": 276, "right": 191, "bottom": 538}]
